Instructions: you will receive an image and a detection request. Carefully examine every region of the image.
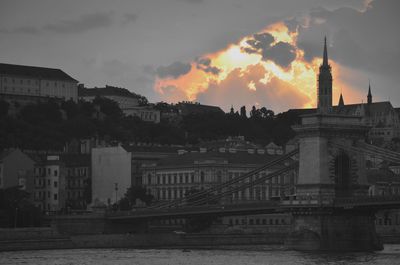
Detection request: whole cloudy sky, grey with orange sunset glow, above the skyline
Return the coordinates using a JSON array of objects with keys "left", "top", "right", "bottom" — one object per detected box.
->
[{"left": 0, "top": 0, "right": 400, "bottom": 112}]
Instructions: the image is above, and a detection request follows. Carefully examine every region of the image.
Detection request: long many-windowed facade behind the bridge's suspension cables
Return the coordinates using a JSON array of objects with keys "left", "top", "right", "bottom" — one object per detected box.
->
[{"left": 142, "top": 149, "right": 296, "bottom": 203}]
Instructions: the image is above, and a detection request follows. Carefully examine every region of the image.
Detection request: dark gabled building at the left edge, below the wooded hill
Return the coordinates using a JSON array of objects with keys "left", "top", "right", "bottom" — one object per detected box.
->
[{"left": 0, "top": 149, "right": 35, "bottom": 193}]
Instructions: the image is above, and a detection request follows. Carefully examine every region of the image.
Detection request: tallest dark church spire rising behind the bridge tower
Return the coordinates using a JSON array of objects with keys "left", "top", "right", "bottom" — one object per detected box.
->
[{"left": 317, "top": 37, "right": 332, "bottom": 113}]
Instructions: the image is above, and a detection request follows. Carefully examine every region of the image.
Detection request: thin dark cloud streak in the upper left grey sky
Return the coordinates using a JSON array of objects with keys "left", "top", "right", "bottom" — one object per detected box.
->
[{"left": 44, "top": 12, "right": 113, "bottom": 33}]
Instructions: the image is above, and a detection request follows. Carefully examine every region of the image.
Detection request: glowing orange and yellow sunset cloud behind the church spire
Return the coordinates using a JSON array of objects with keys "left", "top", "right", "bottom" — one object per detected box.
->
[{"left": 154, "top": 22, "right": 360, "bottom": 111}]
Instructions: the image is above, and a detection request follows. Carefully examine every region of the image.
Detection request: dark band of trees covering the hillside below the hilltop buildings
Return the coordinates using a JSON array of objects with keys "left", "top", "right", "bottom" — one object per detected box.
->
[{"left": 0, "top": 98, "right": 296, "bottom": 150}]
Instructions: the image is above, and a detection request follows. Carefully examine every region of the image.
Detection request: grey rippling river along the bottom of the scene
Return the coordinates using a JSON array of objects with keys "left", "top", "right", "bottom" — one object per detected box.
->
[{"left": 0, "top": 245, "right": 400, "bottom": 265}]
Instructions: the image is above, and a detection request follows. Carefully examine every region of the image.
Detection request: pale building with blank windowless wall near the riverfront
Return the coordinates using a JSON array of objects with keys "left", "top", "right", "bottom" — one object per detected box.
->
[{"left": 92, "top": 146, "right": 132, "bottom": 205}]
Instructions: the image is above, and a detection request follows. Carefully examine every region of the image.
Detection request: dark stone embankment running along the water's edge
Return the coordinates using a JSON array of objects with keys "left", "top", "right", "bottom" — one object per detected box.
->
[{"left": 0, "top": 228, "right": 400, "bottom": 251}]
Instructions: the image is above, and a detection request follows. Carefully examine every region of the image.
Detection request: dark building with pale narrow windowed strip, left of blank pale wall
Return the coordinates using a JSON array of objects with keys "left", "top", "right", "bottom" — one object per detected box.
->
[{"left": 33, "top": 154, "right": 90, "bottom": 212}]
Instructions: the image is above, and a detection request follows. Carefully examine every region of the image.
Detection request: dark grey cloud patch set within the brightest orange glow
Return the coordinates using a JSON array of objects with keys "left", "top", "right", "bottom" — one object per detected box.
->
[{"left": 243, "top": 33, "right": 296, "bottom": 67}]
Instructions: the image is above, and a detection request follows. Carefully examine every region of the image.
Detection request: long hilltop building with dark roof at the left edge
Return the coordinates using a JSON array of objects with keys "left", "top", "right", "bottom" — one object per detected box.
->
[{"left": 0, "top": 63, "right": 78, "bottom": 104}]
